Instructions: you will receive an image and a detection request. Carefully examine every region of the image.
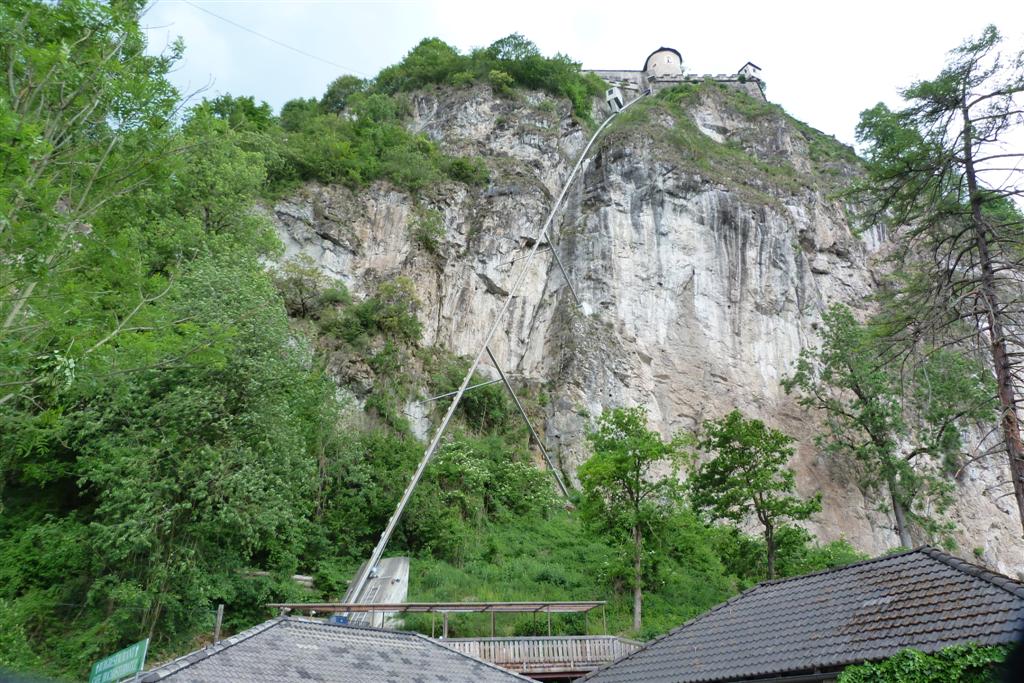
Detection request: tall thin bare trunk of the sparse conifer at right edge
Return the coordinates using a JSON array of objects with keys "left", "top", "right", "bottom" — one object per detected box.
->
[{"left": 962, "top": 104, "right": 1024, "bottom": 529}]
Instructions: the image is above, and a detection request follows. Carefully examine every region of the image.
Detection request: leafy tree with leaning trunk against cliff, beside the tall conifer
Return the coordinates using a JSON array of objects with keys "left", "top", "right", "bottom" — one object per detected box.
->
[{"left": 782, "top": 304, "right": 994, "bottom": 548}]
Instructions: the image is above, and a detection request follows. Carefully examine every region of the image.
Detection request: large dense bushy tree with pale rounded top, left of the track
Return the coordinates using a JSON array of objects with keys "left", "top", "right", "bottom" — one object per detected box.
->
[{"left": 67, "top": 258, "right": 330, "bottom": 638}]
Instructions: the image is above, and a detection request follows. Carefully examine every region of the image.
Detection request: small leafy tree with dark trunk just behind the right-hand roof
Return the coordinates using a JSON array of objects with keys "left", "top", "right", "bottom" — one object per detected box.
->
[{"left": 686, "top": 411, "right": 821, "bottom": 580}]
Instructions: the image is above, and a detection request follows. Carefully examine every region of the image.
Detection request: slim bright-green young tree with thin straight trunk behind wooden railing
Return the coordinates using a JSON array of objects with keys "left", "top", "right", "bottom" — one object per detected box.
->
[{"left": 579, "top": 408, "right": 682, "bottom": 631}]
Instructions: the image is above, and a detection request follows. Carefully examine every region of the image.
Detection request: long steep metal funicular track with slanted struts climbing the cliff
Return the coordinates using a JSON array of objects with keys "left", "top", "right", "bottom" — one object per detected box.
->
[{"left": 347, "top": 97, "right": 640, "bottom": 602}]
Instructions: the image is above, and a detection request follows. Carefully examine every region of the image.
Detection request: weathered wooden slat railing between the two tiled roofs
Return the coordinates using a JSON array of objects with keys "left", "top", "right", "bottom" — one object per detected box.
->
[{"left": 438, "top": 636, "right": 643, "bottom": 674}]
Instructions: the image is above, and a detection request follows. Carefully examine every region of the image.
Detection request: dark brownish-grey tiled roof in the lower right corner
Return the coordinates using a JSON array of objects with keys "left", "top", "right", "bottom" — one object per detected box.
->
[{"left": 586, "top": 547, "right": 1024, "bottom": 683}]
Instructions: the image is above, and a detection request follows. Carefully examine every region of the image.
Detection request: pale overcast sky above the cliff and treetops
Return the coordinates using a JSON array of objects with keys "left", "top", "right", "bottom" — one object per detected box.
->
[{"left": 142, "top": 0, "right": 1024, "bottom": 142}]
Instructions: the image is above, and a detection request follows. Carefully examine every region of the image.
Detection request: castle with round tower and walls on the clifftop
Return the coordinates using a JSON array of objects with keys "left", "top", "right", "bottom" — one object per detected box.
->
[{"left": 585, "top": 47, "right": 767, "bottom": 110}]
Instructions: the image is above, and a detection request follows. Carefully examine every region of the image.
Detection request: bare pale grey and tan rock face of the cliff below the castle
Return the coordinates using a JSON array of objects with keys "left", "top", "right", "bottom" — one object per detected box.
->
[{"left": 273, "top": 83, "right": 1024, "bottom": 574}]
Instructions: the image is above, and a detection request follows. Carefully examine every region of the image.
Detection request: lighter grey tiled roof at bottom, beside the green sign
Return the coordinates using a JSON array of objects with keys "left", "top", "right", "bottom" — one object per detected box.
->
[{"left": 142, "top": 616, "right": 529, "bottom": 683}]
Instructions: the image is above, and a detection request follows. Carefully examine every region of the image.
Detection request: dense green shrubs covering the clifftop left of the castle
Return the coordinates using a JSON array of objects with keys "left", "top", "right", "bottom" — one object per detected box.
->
[{"left": 266, "top": 35, "right": 604, "bottom": 195}]
